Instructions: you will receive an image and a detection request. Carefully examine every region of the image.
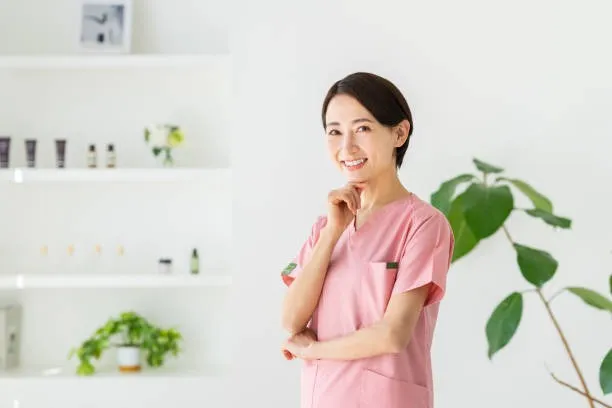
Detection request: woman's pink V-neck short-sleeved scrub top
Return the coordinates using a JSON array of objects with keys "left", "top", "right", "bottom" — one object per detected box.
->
[{"left": 281, "top": 194, "right": 454, "bottom": 408}]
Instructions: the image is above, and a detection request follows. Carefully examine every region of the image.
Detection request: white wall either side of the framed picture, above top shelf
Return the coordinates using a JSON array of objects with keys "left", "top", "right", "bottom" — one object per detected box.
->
[{"left": 0, "top": 0, "right": 230, "bottom": 54}]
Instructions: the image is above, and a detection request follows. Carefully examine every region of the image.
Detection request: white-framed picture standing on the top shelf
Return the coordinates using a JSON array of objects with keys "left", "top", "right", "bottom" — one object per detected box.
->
[{"left": 79, "top": 0, "right": 133, "bottom": 54}]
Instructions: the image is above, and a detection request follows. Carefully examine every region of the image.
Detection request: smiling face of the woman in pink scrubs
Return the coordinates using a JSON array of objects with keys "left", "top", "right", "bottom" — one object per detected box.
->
[{"left": 325, "top": 95, "right": 407, "bottom": 182}]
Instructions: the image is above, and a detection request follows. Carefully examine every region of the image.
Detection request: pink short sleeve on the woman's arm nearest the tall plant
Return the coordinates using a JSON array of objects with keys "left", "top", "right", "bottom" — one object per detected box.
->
[{"left": 393, "top": 213, "right": 455, "bottom": 306}]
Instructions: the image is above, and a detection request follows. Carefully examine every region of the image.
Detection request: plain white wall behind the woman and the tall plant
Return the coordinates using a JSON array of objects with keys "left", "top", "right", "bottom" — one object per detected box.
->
[{"left": 232, "top": 0, "right": 612, "bottom": 408}]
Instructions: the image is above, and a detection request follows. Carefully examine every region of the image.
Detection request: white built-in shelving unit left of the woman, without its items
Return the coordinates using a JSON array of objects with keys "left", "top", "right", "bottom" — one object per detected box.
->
[{"left": 0, "top": 0, "right": 232, "bottom": 408}]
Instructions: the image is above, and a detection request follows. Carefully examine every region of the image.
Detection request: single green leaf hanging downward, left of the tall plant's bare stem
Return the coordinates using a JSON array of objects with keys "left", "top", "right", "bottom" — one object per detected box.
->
[{"left": 486, "top": 292, "right": 523, "bottom": 360}]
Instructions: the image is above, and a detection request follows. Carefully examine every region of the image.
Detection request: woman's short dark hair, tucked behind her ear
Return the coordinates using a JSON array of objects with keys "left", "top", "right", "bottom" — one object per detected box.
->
[{"left": 321, "top": 72, "right": 414, "bottom": 169}]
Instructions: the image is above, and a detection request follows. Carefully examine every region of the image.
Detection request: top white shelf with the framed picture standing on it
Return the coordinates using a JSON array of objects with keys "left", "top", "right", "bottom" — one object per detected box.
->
[{"left": 0, "top": 54, "right": 229, "bottom": 69}]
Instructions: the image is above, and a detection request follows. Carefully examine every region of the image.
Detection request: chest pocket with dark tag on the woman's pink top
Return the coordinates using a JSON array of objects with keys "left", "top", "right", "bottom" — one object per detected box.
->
[{"left": 360, "top": 262, "right": 399, "bottom": 324}]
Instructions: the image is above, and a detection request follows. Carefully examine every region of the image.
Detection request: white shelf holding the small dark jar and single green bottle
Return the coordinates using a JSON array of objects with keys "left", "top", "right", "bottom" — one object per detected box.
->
[{"left": 0, "top": 272, "right": 232, "bottom": 289}]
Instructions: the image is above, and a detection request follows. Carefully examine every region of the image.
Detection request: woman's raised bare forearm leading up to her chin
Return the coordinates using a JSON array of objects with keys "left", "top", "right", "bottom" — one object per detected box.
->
[{"left": 282, "top": 227, "right": 340, "bottom": 335}]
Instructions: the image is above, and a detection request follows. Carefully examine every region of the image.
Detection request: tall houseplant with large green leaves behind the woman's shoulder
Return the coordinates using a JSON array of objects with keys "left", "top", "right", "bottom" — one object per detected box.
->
[{"left": 431, "top": 159, "right": 612, "bottom": 408}]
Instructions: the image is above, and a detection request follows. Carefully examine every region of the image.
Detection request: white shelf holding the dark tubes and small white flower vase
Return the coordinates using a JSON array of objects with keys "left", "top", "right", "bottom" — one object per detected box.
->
[{"left": 0, "top": 168, "right": 231, "bottom": 183}]
